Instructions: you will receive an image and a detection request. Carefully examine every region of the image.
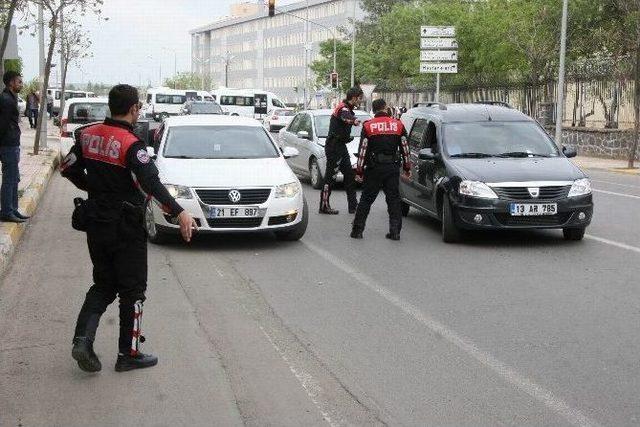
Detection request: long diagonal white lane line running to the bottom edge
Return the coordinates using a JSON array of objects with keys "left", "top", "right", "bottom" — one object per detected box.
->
[{"left": 303, "top": 241, "right": 600, "bottom": 427}]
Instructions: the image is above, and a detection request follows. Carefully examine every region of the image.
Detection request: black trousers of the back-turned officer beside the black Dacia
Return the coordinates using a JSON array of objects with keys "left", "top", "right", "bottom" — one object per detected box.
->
[{"left": 353, "top": 163, "right": 402, "bottom": 233}]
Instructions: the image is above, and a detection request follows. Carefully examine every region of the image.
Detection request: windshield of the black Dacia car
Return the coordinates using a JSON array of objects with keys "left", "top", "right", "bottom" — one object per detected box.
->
[{"left": 443, "top": 122, "right": 559, "bottom": 157}]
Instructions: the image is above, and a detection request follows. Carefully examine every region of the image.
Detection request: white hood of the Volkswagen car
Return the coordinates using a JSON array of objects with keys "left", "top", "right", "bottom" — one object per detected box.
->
[{"left": 158, "top": 157, "right": 297, "bottom": 188}]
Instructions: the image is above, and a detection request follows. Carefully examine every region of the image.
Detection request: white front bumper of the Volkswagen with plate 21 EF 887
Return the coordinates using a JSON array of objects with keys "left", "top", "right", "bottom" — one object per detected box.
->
[{"left": 153, "top": 190, "right": 304, "bottom": 234}]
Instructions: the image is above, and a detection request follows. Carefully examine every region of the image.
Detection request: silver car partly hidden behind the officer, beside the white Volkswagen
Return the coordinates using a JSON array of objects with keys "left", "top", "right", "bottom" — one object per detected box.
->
[{"left": 278, "top": 110, "right": 371, "bottom": 189}]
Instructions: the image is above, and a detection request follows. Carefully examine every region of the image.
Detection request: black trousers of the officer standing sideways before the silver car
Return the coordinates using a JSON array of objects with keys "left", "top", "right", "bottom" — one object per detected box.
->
[{"left": 320, "top": 140, "right": 358, "bottom": 209}]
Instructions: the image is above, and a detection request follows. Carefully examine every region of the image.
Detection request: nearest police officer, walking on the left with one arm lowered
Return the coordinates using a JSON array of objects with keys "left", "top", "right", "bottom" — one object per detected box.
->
[{"left": 61, "top": 85, "right": 196, "bottom": 372}]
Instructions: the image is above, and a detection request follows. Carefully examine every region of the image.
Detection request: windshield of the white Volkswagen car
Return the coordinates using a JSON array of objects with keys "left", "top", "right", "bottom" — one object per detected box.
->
[{"left": 163, "top": 126, "right": 279, "bottom": 161}]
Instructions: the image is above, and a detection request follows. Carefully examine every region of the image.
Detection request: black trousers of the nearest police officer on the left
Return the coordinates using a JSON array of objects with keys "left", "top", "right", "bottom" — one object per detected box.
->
[{"left": 75, "top": 222, "right": 147, "bottom": 354}]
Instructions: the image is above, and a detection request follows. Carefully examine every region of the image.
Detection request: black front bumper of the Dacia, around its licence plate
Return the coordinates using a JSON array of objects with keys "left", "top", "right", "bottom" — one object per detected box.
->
[{"left": 452, "top": 195, "right": 593, "bottom": 230}]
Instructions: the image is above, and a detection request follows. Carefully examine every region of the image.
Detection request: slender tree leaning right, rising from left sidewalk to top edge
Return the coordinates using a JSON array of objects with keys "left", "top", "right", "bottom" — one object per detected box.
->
[{"left": 31, "top": 0, "right": 103, "bottom": 154}]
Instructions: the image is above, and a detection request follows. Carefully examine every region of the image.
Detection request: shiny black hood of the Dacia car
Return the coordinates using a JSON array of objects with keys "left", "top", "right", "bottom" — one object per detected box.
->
[{"left": 449, "top": 157, "right": 585, "bottom": 182}]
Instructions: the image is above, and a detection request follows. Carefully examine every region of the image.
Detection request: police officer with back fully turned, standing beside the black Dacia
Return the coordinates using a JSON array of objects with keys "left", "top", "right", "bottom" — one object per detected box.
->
[{"left": 351, "top": 99, "right": 411, "bottom": 240}]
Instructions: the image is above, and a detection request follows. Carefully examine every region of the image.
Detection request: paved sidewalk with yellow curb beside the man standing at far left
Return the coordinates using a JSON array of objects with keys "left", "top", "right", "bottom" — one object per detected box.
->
[{"left": 0, "top": 121, "right": 60, "bottom": 274}]
